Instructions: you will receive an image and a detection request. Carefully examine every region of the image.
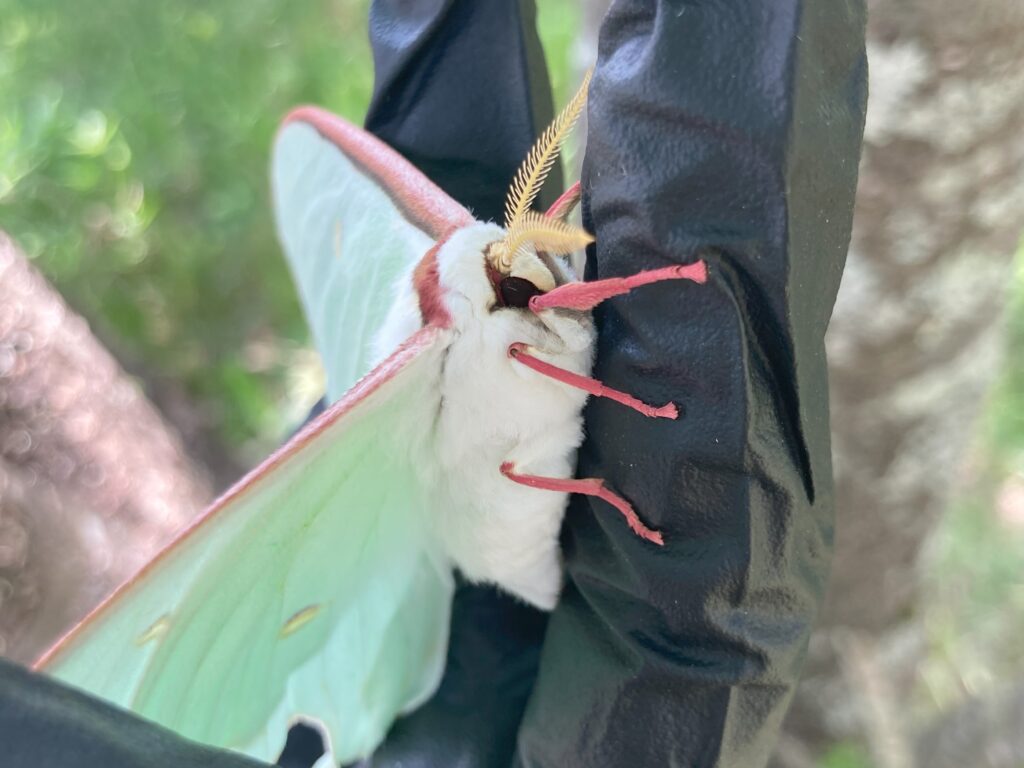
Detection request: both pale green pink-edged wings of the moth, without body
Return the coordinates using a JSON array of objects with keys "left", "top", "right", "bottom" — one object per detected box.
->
[{"left": 40, "top": 108, "right": 472, "bottom": 763}]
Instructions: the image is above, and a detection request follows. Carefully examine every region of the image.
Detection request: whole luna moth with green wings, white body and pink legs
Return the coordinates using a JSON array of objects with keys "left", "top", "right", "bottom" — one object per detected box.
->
[{"left": 29, "top": 75, "right": 707, "bottom": 765}]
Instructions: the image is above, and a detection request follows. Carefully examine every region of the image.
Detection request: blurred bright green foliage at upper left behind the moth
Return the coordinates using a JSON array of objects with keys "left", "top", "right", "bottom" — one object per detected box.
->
[{"left": 0, "top": 0, "right": 578, "bottom": 461}]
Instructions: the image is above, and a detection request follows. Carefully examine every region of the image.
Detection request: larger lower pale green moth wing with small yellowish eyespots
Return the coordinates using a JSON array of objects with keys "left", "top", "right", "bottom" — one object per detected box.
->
[{"left": 37, "top": 327, "right": 453, "bottom": 764}]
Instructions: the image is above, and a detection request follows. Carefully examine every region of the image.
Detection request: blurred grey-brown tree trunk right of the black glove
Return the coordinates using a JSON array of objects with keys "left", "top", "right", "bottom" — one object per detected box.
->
[{"left": 825, "top": 0, "right": 1024, "bottom": 631}]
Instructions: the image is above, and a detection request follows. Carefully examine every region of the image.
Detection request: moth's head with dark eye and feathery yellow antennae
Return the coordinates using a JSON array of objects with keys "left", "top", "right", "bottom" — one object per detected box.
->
[{"left": 485, "top": 72, "right": 594, "bottom": 307}]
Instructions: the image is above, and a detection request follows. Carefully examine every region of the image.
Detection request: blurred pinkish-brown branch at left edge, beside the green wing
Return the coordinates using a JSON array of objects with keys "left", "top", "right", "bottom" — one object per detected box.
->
[{"left": 0, "top": 232, "right": 210, "bottom": 663}]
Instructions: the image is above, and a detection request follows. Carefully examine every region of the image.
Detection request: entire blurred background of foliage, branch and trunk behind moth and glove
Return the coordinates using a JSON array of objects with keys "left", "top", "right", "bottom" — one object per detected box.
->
[{"left": 0, "top": 0, "right": 1024, "bottom": 768}]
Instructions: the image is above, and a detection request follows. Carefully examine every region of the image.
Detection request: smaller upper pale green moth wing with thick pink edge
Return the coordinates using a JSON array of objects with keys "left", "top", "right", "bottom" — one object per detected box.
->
[{"left": 271, "top": 106, "right": 472, "bottom": 401}]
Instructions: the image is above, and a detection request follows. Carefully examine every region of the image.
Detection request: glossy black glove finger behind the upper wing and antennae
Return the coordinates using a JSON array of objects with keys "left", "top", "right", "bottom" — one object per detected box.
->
[{"left": 366, "top": 0, "right": 561, "bottom": 221}]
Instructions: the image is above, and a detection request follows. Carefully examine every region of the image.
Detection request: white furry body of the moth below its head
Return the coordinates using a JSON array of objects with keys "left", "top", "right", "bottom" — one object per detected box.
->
[{"left": 436, "top": 309, "right": 591, "bottom": 608}]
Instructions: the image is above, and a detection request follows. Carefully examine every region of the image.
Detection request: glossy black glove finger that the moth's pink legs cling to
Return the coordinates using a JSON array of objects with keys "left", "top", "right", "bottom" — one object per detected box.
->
[{"left": 518, "top": 0, "right": 866, "bottom": 768}]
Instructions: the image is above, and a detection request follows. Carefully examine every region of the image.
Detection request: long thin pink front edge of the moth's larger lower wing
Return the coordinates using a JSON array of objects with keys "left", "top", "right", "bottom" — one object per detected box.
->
[{"left": 32, "top": 326, "right": 443, "bottom": 671}]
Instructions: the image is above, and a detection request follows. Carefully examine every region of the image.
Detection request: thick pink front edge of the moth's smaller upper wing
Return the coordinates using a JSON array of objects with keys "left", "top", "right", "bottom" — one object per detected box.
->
[{"left": 282, "top": 106, "right": 473, "bottom": 240}]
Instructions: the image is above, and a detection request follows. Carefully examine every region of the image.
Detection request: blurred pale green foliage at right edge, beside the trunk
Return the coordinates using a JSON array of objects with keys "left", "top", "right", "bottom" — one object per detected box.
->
[{"left": 920, "top": 250, "right": 1024, "bottom": 711}]
